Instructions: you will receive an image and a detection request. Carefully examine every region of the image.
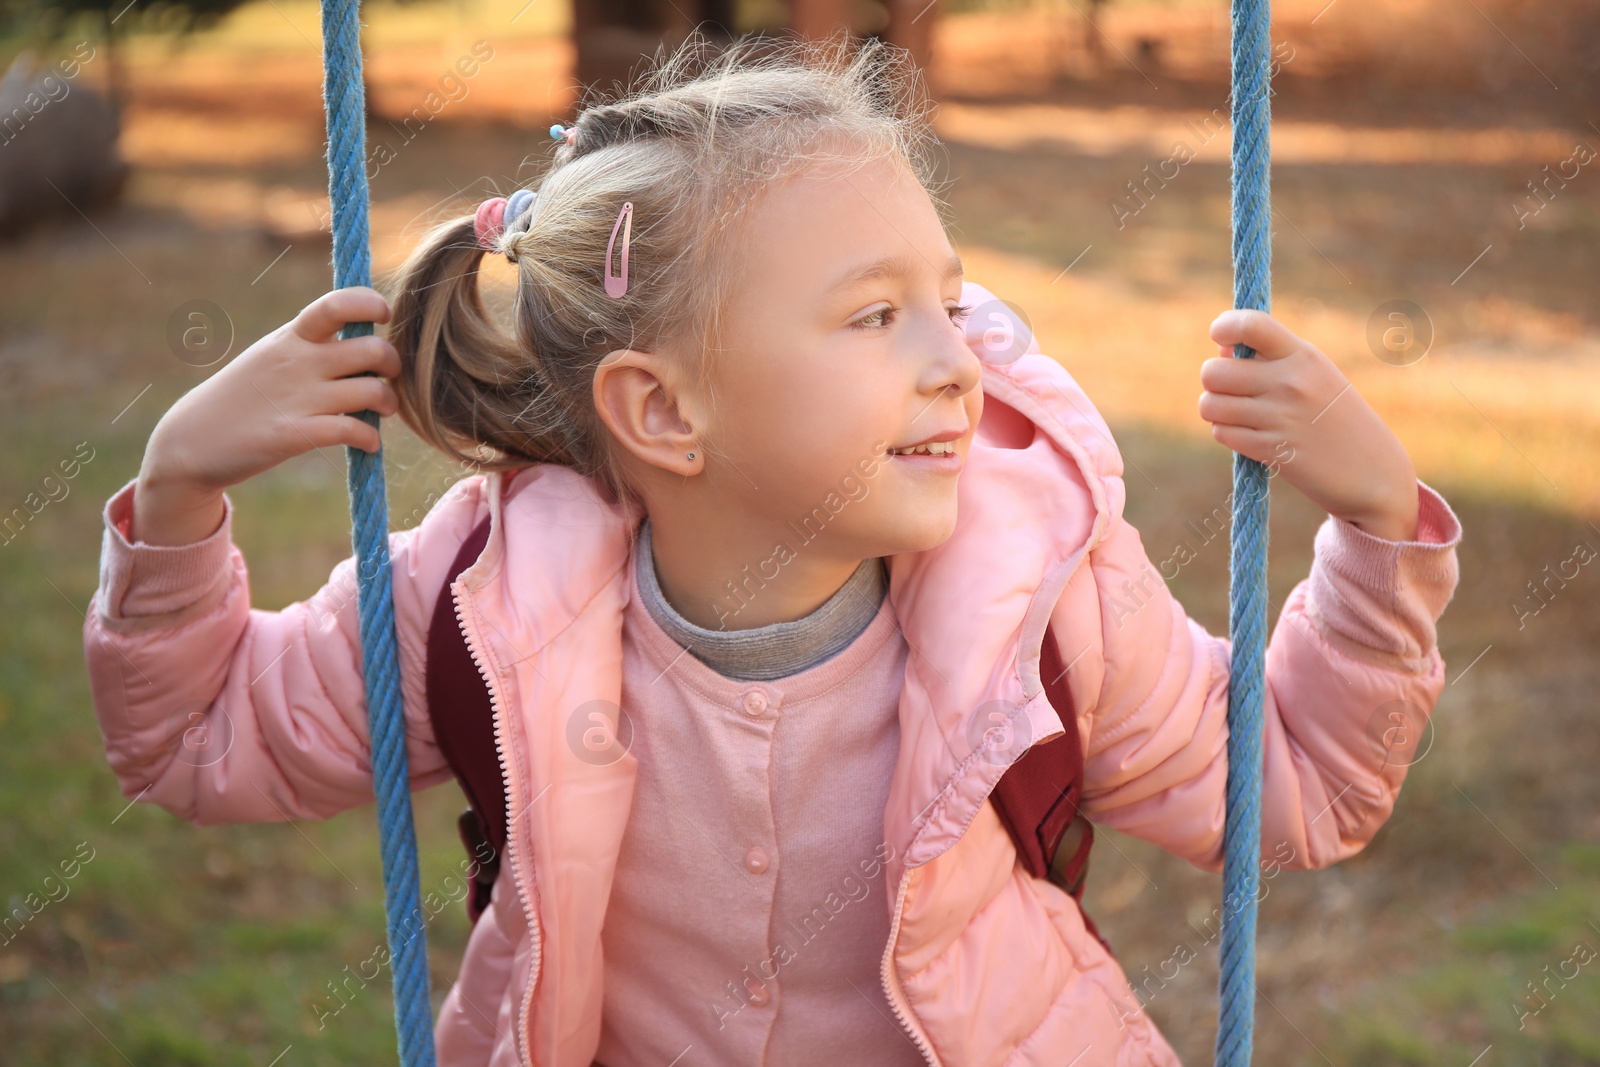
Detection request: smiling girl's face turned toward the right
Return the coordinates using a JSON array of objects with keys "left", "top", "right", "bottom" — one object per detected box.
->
[{"left": 706, "top": 160, "right": 982, "bottom": 558}]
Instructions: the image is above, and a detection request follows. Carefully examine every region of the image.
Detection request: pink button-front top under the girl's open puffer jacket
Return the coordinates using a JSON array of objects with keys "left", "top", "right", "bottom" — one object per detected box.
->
[{"left": 597, "top": 527, "right": 923, "bottom": 1067}]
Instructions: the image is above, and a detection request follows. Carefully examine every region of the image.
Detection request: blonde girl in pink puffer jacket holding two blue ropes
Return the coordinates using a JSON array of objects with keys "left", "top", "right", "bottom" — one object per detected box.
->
[{"left": 85, "top": 29, "right": 1461, "bottom": 1067}]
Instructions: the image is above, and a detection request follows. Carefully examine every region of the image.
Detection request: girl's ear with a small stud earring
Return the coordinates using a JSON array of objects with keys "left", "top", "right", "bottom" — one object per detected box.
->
[{"left": 594, "top": 349, "right": 706, "bottom": 475}]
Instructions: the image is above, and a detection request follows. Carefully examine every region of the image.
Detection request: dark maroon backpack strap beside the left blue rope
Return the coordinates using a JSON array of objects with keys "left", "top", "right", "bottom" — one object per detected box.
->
[{"left": 426, "top": 518, "right": 506, "bottom": 923}]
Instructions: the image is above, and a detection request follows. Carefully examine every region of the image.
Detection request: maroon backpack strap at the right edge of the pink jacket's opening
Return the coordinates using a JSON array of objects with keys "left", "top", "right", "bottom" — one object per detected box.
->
[{"left": 989, "top": 625, "right": 1110, "bottom": 952}]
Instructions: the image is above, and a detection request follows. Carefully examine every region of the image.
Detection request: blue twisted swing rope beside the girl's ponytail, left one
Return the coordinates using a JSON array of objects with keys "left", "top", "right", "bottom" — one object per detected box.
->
[{"left": 322, "top": 0, "right": 434, "bottom": 1067}]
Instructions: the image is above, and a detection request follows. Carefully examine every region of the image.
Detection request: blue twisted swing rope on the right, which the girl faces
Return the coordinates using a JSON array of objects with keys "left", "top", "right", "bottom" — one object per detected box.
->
[{"left": 1216, "top": 0, "right": 1272, "bottom": 1067}]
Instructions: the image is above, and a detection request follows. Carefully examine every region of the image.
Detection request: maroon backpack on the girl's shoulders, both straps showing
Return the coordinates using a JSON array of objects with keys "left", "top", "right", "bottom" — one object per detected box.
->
[{"left": 426, "top": 518, "right": 1110, "bottom": 952}]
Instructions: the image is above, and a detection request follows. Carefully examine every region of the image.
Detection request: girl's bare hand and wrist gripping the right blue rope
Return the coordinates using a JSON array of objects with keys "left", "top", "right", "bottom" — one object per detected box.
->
[{"left": 1200, "top": 309, "right": 1418, "bottom": 541}]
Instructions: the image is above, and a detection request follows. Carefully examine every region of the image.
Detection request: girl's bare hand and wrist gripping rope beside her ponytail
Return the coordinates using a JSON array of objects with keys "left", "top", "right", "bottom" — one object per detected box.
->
[{"left": 133, "top": 285, "right": 400, "bottom": 544}]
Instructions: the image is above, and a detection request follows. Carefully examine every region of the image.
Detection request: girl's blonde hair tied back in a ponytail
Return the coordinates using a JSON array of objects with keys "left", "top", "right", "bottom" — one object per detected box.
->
[{"left": 386, "top": 29, "right": 944, "bottom": 526}]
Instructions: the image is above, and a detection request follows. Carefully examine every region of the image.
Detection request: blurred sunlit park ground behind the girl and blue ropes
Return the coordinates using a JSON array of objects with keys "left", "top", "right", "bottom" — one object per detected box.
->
[{"left": 0, "top": 0, "right": 1600, "bottom": 1067}]
